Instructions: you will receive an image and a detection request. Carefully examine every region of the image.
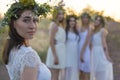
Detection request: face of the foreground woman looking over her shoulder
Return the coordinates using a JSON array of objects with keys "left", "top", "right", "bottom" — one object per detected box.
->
[{"left": 14, "top": 10, "right": 38, "bottom": 39}]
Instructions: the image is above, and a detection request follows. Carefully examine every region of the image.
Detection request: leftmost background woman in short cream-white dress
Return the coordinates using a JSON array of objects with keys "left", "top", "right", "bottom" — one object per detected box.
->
[{"left": 46, "top": 7, "right": 66, "bottom": 80}]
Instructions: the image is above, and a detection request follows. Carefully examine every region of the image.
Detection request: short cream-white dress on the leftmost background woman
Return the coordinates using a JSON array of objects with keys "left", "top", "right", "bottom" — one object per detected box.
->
[{"left": 46, "top": 23, "right": 66, "bottom": 69}]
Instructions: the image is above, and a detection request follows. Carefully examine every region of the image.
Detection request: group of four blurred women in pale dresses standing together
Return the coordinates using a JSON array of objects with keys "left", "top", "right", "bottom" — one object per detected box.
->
[{"left": 46, "top": 8, "right": 113, "bottom": 80}]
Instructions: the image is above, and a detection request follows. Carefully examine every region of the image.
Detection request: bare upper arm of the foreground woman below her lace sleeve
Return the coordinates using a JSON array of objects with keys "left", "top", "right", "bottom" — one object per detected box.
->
[{"left": 20, "top": 66, "right": 38, "bottom": 80}]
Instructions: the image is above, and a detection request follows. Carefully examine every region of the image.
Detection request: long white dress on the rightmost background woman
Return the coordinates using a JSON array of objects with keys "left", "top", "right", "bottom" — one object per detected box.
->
[{"left": 91, "top": 29, "right": 113, "bottom": 80}]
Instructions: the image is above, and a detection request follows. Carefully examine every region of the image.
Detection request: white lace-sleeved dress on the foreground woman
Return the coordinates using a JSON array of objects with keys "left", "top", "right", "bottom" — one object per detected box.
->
[{"left": 6, "top": 46, "right": 51, "bottom": 80}]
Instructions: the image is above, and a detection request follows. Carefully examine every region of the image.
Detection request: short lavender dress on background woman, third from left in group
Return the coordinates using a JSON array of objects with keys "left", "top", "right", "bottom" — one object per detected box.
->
[{"left": 78, "top": 29, "right": 90, "bottom": 73}]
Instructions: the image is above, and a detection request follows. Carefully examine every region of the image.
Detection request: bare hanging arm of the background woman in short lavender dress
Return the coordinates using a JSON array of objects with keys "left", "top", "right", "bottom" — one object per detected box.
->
[{"left": 80, "top": 28, "right": 92, "bottom": 62}]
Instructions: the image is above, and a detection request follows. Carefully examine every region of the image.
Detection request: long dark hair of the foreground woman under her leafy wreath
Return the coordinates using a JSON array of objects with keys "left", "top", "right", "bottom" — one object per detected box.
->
[{"left": 3, "top": 4, "right": 30, "bottom": 64}]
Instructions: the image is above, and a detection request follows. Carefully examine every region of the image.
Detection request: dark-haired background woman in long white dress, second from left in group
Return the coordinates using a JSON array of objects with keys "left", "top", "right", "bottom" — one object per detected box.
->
[{"left": 65, "top": 15, "right": 79, "bottom": 80}]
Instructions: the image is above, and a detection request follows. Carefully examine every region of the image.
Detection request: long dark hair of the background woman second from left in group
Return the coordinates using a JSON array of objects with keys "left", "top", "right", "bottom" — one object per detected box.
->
[{"left": 65, "top": 15, "right": 79, "bottom": 40}]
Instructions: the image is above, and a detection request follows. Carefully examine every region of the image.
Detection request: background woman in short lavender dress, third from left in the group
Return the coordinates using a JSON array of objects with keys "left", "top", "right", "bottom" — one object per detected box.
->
[{"left": 79, "top": 13, "right": 92, "bottom": 80}]
